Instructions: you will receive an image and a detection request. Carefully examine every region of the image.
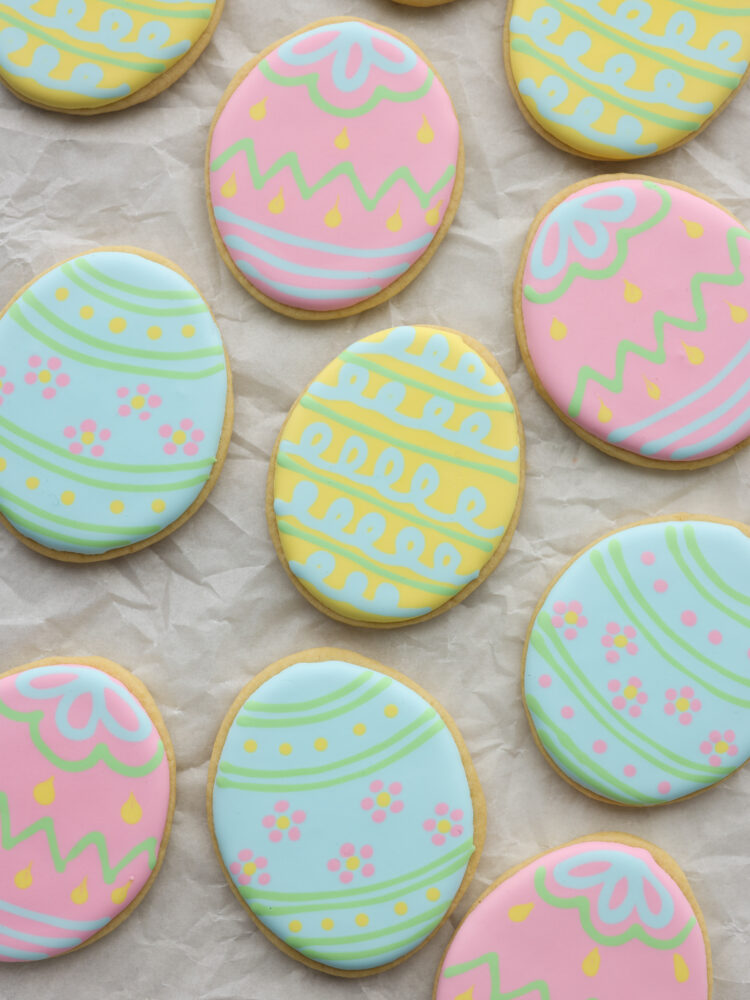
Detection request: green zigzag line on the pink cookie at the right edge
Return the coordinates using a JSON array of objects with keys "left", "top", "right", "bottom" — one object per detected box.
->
[{"left": 568, "top": 226, "right": 750, "bottom": 417}]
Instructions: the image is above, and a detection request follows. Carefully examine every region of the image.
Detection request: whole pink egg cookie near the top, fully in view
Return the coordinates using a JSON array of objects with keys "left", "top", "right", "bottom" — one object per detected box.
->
[{"left": 207, "top": 19, "right": 463, "bottom": 319}]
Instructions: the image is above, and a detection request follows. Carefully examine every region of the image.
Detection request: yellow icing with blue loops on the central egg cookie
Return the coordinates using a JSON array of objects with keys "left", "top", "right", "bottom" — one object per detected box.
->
[{"left": 274, "top": 327, "right": 521, "bottom": 623}]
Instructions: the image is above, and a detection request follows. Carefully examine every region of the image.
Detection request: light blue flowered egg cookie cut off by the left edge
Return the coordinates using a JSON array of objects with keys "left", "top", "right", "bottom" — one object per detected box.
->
[{"left": 0, "top": 248, "right": 232, "bottom": 561}]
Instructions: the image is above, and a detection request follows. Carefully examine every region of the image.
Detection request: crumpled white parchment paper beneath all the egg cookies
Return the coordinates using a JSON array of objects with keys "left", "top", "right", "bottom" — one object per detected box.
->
[{"left": 0, "top": 0, "right": 750, "bottom": 1000}]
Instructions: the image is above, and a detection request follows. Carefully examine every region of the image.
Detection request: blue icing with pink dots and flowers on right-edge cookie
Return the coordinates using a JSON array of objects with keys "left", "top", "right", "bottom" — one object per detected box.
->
[{"left": 524, "top": 520, "right": 750, "bottom": 805}]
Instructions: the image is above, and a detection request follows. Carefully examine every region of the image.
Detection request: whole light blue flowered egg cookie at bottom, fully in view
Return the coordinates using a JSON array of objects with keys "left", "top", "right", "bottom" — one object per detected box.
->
[{"left": 208, "top": 649, "right": 485, "bottom": 976}]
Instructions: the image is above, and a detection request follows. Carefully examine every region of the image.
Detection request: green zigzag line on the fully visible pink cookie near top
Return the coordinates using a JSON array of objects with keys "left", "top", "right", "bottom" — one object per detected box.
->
[{"left": 211, "top": 138, "right": 456, "bottom": 212}]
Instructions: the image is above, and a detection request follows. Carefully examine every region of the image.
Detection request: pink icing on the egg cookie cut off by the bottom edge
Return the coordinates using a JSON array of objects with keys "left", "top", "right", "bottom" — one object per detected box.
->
[{"left": 436, "top": 840, "right": 709, "bottom": 1000}]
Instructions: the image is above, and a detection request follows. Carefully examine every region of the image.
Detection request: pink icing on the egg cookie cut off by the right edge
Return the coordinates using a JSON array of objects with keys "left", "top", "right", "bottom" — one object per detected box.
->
[{"left": 522, "top": 178, "right": 750, "bottom": 463}]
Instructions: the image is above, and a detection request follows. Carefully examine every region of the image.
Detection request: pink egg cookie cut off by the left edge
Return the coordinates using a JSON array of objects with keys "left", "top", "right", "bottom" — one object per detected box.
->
[{"left": 0, "top": 658, "right": 175, "bottom": 962}]
